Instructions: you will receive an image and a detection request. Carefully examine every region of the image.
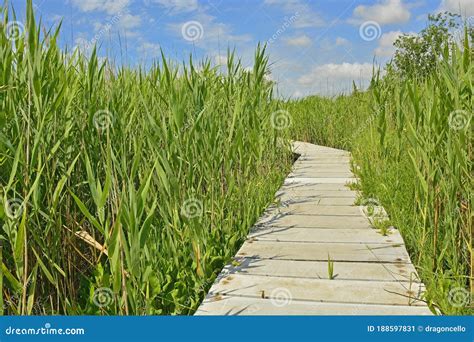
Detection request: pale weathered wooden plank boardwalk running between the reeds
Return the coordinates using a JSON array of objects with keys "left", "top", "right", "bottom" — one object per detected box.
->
[{"left": 196, "top": 142, "right": 431, "bottom": 315}]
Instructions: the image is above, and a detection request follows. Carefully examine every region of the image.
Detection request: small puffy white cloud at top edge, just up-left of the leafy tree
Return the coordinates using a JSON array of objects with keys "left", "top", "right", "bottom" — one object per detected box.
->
[{"left": 350, "top": 0, "right": 411, "bottom": 25}]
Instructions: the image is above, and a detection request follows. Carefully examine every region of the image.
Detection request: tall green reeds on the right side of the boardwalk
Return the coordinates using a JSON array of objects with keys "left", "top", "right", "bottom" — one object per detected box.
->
[{"left": 287, "top": 30, "right": 474, "bottom": 314}]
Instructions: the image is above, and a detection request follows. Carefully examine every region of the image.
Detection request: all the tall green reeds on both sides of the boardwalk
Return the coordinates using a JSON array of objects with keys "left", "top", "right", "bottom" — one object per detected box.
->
[{"left": 0, "top": 1, "right": 473, "bottom": 315}]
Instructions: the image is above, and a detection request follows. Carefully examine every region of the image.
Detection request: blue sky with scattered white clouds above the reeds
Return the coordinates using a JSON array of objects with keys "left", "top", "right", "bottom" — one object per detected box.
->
[{"left": 10, "top": 0, "right": 474, "bottom": 97}]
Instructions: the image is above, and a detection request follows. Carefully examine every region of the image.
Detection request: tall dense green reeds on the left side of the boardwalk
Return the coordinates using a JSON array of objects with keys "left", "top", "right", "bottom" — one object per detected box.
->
[{"left": 0, "top": 1, "right": 292, "bottom": 315}]
